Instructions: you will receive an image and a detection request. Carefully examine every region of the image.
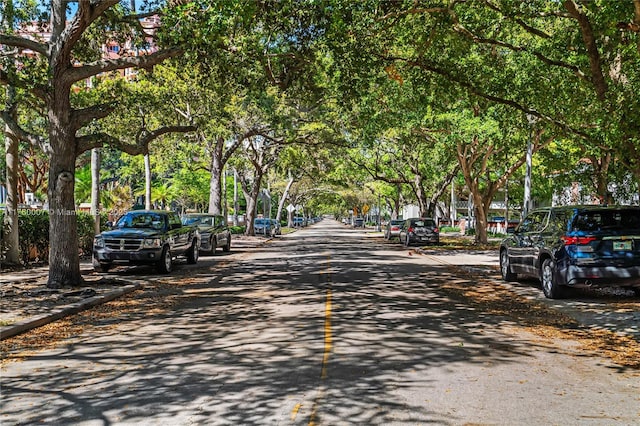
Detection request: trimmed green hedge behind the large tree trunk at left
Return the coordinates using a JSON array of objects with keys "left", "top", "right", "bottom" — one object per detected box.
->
[{"left": 0, "top": 210, "right": 108, "bottom": 264}]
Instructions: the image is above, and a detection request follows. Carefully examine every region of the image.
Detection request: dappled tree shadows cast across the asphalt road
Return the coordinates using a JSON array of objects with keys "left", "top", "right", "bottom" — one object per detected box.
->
[{"left": 2, "top": 225, "right": 636, "bottom": 425}]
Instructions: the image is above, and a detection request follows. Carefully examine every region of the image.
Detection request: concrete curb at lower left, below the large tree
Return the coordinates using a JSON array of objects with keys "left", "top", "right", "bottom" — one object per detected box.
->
[{"left": 0, "top": 283, "right": 142, "bottom": 340}]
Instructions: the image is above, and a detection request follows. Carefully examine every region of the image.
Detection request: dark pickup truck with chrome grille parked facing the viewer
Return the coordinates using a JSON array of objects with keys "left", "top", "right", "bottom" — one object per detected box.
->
[{"left": 93, "top": 210, "right": 200, "bottom": 274}]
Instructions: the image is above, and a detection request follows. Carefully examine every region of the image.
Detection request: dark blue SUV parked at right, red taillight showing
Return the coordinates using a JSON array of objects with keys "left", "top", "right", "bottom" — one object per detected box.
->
[{"left": 500, "top": 206, "right": 640, "bottom": 299}]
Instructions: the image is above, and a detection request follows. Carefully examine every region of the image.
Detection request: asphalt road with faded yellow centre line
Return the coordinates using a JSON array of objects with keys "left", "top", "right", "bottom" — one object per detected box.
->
[{"left": 0, "top": 220, "right": 640, "bottom": 426}]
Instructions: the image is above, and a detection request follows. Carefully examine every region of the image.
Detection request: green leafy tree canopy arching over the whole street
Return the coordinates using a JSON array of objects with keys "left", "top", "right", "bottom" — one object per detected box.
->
[{"left": 0, "top": 0, "right": 640, "bottom": 278}]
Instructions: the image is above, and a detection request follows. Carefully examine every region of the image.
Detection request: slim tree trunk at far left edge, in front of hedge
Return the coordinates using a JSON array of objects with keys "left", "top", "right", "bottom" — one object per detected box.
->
[{"left": 0, "top": 129, "right": 21, "bottom": 265}]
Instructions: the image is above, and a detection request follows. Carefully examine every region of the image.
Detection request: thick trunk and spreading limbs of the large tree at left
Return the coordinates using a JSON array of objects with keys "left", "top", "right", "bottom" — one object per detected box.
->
[{"left": 0, "top": 0, "right": 188, "bottom": 287}]
